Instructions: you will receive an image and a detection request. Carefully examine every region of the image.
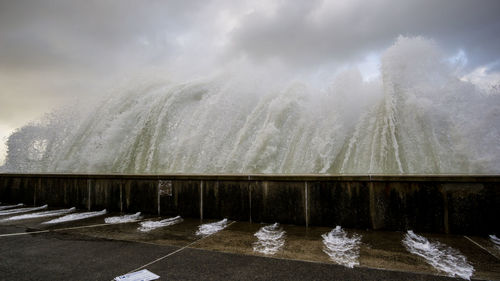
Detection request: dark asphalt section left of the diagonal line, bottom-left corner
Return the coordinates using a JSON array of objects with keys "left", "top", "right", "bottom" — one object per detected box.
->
[{"left": 0, "top": 232, "right": 177, "bottom": 281}]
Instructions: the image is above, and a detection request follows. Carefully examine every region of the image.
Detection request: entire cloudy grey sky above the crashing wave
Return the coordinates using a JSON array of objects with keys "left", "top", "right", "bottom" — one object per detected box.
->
[{"left": 0, "top": 0, "right": 500, "bottom": 164}]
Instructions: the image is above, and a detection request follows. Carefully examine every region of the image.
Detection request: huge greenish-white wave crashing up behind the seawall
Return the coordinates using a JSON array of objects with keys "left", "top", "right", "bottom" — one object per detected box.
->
[{"left": 1, "top": 37, "right": 500, "bottom": 174}]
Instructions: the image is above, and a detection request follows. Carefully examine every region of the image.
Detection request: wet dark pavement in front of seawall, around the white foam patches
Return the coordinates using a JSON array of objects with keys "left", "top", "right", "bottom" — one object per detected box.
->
[{"left": 0, "top": 205, "right": 500, "bottom": 280}]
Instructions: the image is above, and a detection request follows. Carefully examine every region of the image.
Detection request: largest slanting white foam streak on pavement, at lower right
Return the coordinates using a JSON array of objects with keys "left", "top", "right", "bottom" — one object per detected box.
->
[{"left": 403, "top": 230, "right": 474, "bottom": 280}]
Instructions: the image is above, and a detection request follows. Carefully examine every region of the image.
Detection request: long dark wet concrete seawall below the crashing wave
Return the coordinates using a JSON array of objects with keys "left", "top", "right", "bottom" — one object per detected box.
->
[{"left": 0, "top": 174, "right": 500, "bottom": 234}]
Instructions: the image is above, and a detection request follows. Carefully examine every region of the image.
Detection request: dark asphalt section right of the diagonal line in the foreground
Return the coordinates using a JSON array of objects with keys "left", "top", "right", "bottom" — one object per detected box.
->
[{"left": 146, "top": 248, "right": 456, "bottom": 280}]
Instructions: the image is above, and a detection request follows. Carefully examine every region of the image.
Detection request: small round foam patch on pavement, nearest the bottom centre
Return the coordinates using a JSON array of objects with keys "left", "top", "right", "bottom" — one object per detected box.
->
[{"left": 253, "top": 223, "right": 285, "bottom": 255}]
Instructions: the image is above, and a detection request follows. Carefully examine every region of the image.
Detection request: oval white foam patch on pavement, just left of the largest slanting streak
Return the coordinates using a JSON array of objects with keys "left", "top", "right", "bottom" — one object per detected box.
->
[{"left": 321, "top": 226, "right": 361, "bottom": 268}]
